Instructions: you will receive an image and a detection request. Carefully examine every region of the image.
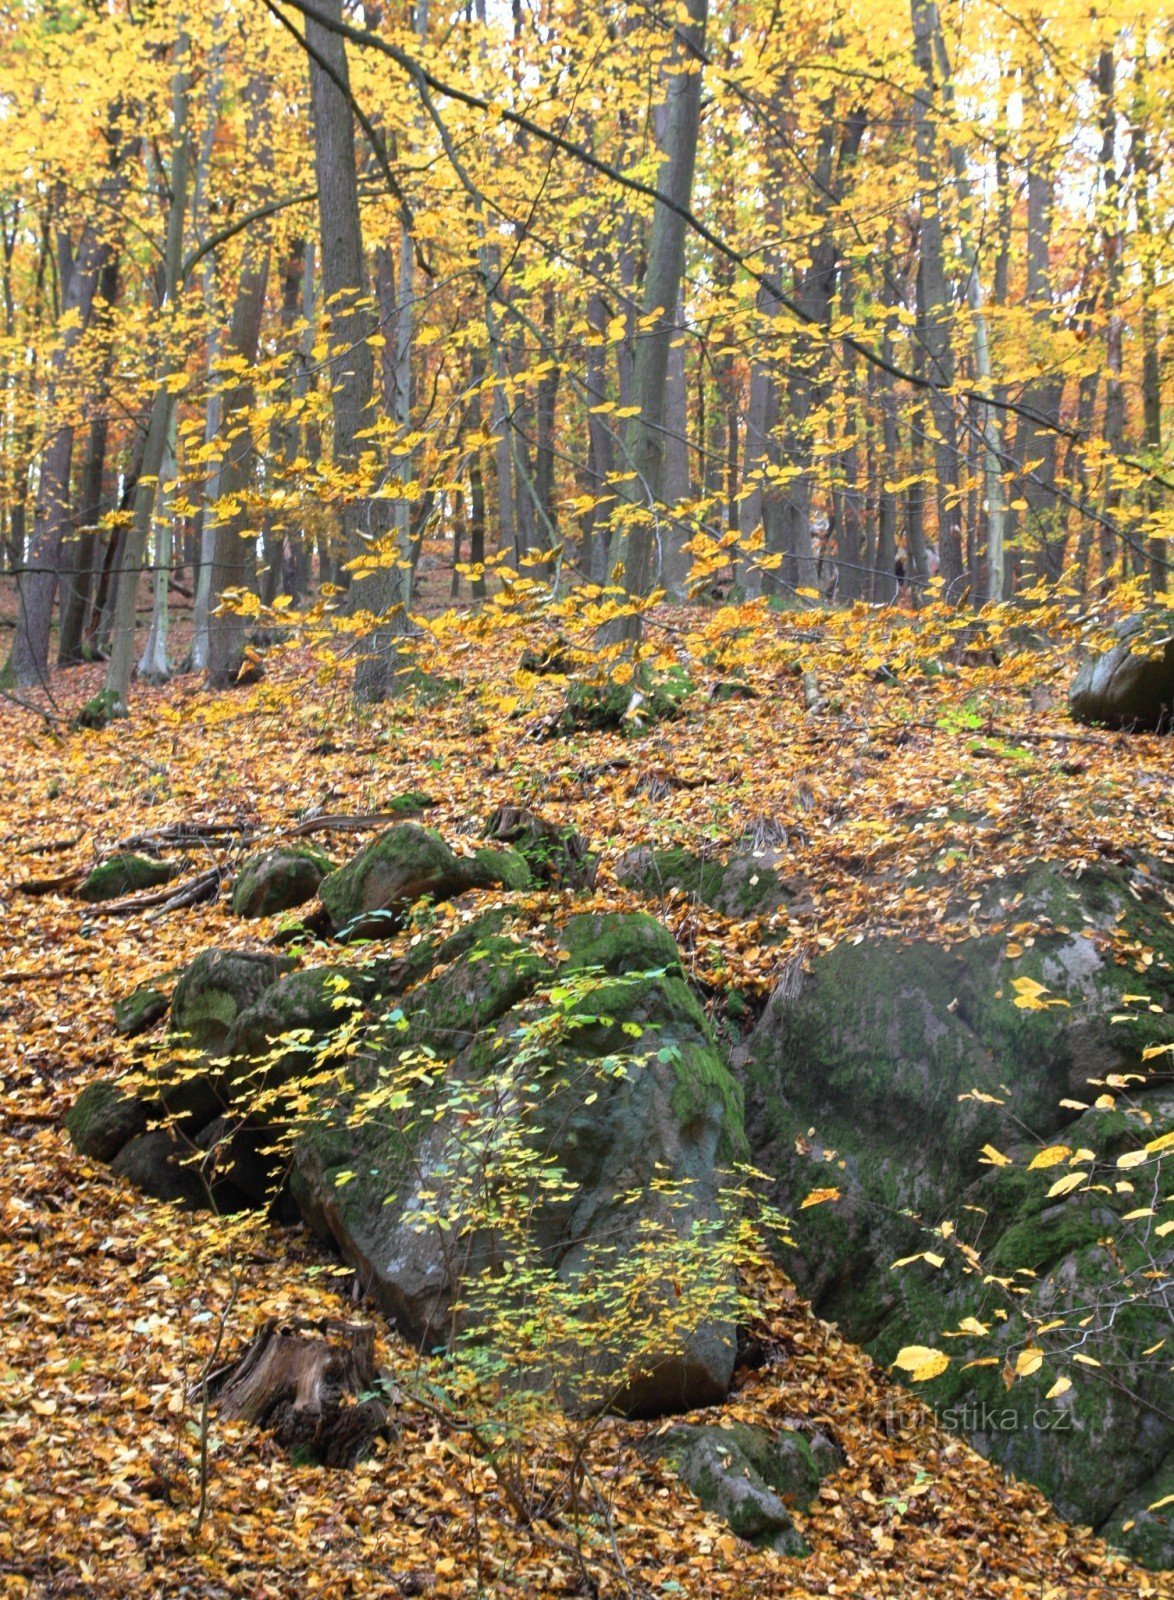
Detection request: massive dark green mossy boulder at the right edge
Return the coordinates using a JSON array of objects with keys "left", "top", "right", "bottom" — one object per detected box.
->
[{"left": 742, "top": 866, "right": 1174, "bottom": 1561}]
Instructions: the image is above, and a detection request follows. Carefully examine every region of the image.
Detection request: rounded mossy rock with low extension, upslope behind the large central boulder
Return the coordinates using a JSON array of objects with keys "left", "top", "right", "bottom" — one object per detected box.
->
[{"left": 318, "top": 822, "right": 529, "bottom": 938}]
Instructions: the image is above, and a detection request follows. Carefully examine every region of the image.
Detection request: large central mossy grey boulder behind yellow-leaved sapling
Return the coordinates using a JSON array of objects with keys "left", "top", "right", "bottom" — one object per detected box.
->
[{"left": 293, "top": 917, "right": 744, "bottom": 1414}]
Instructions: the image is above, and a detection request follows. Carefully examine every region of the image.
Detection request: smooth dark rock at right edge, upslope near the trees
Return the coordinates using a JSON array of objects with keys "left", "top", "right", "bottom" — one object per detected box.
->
[{"left": 1068, "top": 611, "right": 1174, "bottom": 733}]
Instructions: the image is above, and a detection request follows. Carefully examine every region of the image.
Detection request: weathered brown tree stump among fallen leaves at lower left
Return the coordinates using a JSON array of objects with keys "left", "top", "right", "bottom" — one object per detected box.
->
[{"left": 208, "top": 1318, "right": 387, "bottom": 1467}]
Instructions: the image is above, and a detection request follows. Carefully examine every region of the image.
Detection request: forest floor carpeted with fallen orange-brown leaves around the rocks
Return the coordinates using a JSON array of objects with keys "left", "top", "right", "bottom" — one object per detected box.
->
[{"left": 0, "top": 588, "right": 1174, "bottom": 1600}]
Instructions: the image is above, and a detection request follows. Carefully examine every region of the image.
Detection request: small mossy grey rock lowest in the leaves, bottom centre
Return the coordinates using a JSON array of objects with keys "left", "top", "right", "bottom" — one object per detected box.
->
[{"left": 645, "top": 1422, "right": 840, "bottom": 1555}]
